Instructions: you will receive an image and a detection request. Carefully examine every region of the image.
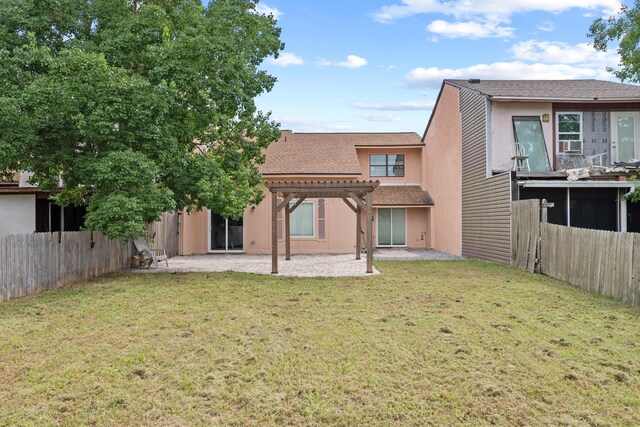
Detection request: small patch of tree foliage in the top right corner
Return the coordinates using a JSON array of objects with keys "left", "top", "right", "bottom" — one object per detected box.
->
[{"left": 587, "top": 0, "right": 640, "bottom": 83}]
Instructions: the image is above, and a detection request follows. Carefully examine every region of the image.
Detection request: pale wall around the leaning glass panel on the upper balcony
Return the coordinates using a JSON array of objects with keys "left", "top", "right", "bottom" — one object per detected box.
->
[{"left": 491, "top": 102, "right": 553, "bottom": 171}]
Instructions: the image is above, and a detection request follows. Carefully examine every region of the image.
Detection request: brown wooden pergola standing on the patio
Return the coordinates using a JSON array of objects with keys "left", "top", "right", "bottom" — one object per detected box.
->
[{"left": 266, "top": 181, "right": 380, "bottom": 274}]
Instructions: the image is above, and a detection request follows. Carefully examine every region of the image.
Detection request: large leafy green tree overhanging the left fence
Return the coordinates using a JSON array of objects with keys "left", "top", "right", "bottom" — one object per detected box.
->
[{"left": 0, "top": 0, "right": 284, "bottom": 238}]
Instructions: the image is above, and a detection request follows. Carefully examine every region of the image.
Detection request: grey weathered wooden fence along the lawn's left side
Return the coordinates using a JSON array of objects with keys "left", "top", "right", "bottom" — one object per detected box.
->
[{"left": 0, "top": 231, "right": 133, "bottom": 301}]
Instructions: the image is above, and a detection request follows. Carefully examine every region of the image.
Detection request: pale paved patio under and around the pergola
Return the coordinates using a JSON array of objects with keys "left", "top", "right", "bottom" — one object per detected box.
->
[{"left": 131, "top": 248, "right": 462, "bottom": 277}]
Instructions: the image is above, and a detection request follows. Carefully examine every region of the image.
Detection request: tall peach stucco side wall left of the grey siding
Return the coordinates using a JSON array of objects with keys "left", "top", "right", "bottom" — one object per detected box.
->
[{"left": 424, "top": 85, "right": 462, "bottom": 255}]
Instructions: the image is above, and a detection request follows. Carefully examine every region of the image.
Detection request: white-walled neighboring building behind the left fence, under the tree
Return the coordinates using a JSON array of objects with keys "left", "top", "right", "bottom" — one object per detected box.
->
[{"left": 0, "top": 172, "right": 86, "bottom": 236}]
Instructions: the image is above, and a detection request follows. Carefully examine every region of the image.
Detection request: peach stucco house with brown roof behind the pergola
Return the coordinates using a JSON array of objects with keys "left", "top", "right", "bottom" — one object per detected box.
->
[{"left": 180, "top": 131, "right": 433, "bottom": 255}]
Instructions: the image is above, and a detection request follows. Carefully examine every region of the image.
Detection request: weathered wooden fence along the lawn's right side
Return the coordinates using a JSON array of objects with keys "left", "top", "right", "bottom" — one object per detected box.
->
[{"left": 511, "top": 200, "right": 640, "bottom": 307}]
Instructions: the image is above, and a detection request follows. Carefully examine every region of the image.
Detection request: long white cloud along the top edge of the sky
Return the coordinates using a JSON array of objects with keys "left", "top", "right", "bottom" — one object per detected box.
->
[{"left": 373, "top": 0, "right": 622, "bottom": 23}]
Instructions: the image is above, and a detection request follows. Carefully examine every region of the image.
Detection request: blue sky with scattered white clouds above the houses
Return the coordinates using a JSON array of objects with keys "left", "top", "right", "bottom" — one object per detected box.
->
[{"left": 250, "top": 0, "right": 622, "bottom": 135}]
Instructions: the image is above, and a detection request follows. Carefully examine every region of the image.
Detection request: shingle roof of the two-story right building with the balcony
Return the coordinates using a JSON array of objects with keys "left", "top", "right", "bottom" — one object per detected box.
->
[{"left": 445, "top": 80, "right": 640, "bottom": 101}]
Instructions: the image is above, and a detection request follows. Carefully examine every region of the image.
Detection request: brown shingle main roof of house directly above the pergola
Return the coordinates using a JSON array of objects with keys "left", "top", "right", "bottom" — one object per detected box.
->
[{"left": 260, "top": 130, "right": 423, "bottom": 175}]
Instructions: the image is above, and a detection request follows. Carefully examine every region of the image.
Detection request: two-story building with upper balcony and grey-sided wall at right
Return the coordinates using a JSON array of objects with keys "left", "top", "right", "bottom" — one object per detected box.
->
[{"left": 423, "top": 80, "right": 640, "bottom": 264}]
